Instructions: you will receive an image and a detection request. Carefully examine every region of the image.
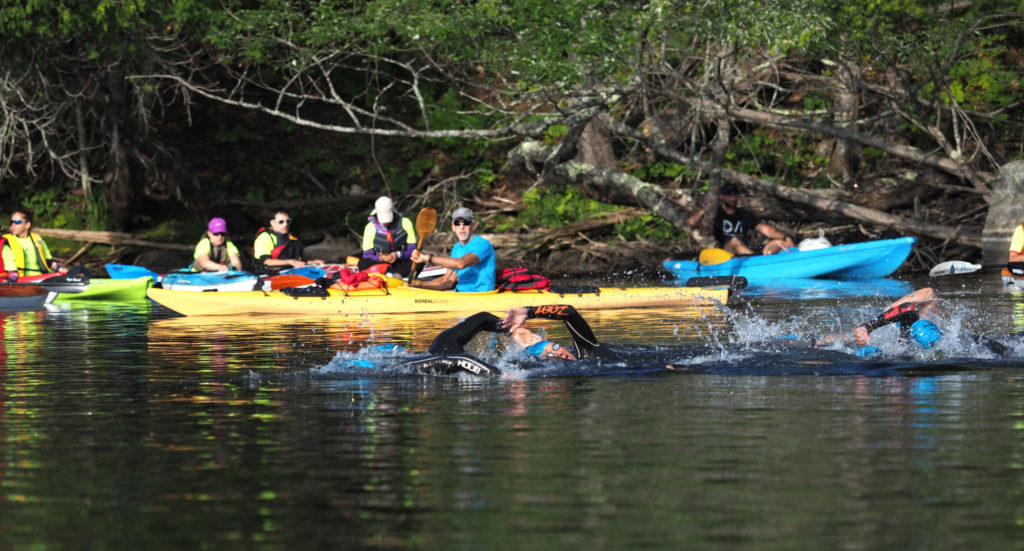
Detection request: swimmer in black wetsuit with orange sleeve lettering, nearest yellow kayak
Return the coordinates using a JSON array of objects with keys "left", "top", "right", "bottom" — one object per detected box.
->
[{"left": 402, "top": 304, "right": 614, "bottom": 376}]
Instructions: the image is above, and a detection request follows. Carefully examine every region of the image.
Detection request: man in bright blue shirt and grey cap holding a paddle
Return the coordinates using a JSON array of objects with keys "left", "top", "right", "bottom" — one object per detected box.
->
[{"left": 412, "top": 207, "right": 495, "bottom": 293}]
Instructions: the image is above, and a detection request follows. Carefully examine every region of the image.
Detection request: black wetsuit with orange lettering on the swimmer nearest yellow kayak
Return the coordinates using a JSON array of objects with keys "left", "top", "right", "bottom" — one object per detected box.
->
[{"left": 404, "top": 304, "right": 614, "bottom": 376}]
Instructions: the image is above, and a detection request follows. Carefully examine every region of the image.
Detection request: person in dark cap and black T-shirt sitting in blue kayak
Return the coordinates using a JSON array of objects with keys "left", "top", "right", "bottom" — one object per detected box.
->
[{"left": 686, "top": 183, "right": 795, "bottom": 255}]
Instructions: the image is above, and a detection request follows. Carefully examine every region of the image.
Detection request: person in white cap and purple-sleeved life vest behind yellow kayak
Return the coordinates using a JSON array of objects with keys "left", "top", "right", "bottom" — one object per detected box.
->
[{"left": 358, "top": 197, "right": 416, "bottom": 278}]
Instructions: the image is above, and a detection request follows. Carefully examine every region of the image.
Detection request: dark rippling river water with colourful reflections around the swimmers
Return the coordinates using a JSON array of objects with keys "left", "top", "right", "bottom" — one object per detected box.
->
[{"left": 0, "top": 274, "right": 1024, "bottom": 549}]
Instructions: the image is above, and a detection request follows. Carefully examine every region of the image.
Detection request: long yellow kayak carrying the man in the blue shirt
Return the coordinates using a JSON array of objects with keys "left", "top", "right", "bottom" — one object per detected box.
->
[{"left": 148, "top": 279, "right": 729, "bottom": 315}]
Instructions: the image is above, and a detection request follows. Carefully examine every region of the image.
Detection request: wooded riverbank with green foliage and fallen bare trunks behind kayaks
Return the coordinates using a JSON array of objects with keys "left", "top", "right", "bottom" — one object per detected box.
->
[{"left": 0, "top": 0, "right": 1024, "bottom": 277}]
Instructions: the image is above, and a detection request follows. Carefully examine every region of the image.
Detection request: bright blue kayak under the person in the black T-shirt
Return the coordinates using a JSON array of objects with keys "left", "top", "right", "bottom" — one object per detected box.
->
[{"left": 663, "top": 238, "right": 916, "bottom": 280}]
